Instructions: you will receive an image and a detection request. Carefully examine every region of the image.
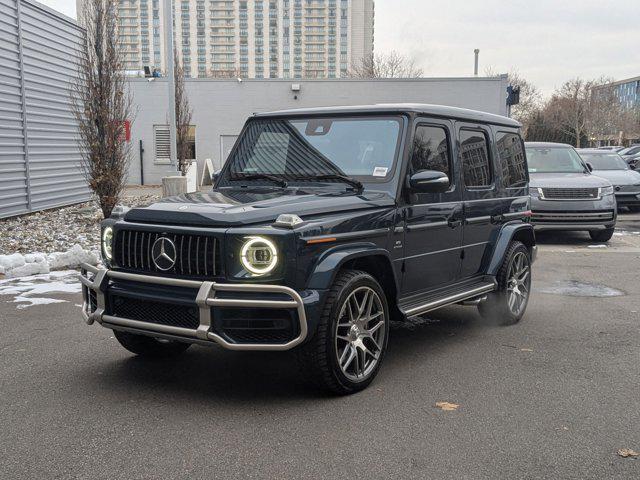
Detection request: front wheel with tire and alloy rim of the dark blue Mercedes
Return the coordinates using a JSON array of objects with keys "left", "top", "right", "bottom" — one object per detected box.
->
[{"left": 298, "top": 270, "right": 389, "bottom": 395}]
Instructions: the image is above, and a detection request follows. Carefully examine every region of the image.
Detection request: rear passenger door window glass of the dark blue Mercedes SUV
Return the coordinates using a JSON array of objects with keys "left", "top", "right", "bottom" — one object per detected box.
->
[{"left": 460, "top": 129, "right": 493, "bottom": 187}]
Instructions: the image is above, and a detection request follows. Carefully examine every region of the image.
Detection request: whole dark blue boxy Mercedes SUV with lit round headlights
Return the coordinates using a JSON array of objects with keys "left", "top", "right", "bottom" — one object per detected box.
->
[{"left": 81, "top": 105, "right": 536, "bottom": 394}]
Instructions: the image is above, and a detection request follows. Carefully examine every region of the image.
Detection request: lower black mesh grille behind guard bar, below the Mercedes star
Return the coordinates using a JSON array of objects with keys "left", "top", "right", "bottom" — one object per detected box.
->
[{"left": 109, "top": 295, "right": 200, "bottom": 330}]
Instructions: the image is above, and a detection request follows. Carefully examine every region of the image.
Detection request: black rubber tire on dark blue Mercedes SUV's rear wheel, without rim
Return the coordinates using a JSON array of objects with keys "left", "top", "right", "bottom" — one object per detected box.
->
[{"left": 478, "top": 241, "right": 531, "bottom": 325}]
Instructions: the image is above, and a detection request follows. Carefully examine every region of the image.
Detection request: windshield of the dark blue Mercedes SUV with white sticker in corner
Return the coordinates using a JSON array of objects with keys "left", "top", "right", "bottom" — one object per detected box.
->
[{"left": 221, "top": 117, "right": 401, "bottom": 185}]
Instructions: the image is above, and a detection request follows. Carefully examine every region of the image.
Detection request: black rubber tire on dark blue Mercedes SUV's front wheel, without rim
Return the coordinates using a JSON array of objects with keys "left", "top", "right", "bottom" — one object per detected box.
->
[{"left": 297, "top": 270, "right": 390, "bottom": 395}]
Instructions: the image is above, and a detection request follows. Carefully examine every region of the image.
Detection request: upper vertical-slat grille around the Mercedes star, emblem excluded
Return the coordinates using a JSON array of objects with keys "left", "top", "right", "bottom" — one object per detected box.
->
[{"left": 113, "top": 230, "right": 222, "bottom": 277}]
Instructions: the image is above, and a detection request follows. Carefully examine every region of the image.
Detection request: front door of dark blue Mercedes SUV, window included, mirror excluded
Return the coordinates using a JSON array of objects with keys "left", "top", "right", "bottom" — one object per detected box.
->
[{"left": 402, "top": 119, "right": 463, "bottom": 296}]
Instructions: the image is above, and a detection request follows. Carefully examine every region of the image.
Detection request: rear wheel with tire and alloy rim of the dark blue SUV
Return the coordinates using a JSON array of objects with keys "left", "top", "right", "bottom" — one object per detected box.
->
[{"left": 478, "top": 241, "right": 531, "bottom": 325}]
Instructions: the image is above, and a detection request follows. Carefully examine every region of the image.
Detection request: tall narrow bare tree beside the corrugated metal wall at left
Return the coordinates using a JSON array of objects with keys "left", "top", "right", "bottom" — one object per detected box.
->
[{"left": 71, "top": 0, "right": 132, "bottom": 218}]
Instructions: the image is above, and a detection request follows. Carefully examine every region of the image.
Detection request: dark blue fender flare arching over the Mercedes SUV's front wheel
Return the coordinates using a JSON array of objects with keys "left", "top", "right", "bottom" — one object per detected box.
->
[{"left": 307, "top": 243, "right": 400, "bottom": 291}]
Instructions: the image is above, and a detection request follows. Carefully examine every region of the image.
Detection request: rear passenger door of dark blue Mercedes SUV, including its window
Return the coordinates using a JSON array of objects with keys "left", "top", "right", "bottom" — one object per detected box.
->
[{"left": 456, "top": 122, "right": 505, "bottom": 279}]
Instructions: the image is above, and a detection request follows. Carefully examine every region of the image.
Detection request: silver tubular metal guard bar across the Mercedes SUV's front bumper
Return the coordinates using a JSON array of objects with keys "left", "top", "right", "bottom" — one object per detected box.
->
[{"left": 79, "top": 264, "right": 310, "bottom": 351}]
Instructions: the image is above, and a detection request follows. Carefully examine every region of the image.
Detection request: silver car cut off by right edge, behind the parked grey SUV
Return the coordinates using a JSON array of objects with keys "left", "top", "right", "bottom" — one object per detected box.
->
[{"left": 578, "top": 149, "right": 640, "bottom": 212}]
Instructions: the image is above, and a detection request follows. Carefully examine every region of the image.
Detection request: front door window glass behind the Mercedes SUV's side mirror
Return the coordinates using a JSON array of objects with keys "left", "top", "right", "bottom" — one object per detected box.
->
[{"left": 411, "top": 125, "right": 451, "bottom": 181}]
